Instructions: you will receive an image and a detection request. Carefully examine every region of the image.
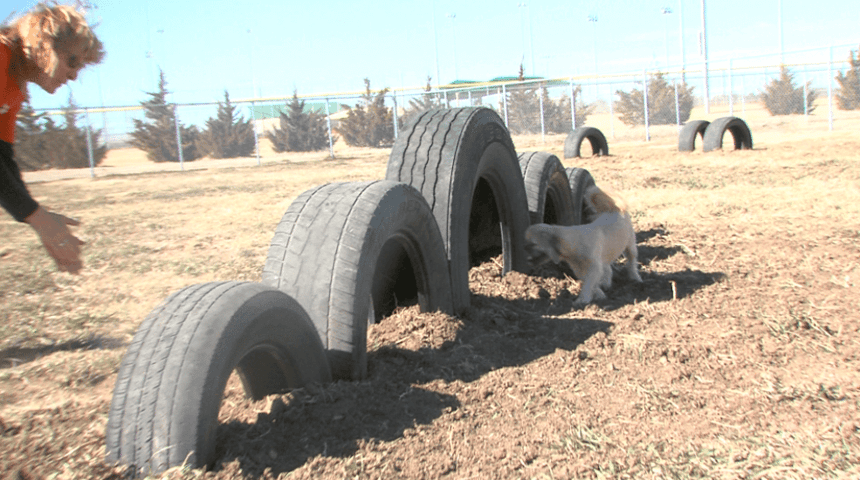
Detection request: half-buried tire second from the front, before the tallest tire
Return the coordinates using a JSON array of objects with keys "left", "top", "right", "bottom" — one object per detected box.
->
[{"left": 263, "top": 180, "right": 453, "bottom": 380}]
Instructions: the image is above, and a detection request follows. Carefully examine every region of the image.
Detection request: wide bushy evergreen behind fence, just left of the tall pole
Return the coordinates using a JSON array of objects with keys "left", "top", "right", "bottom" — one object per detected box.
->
[{"left": 615, "top": 72, "right": 693, "bottom": 125}]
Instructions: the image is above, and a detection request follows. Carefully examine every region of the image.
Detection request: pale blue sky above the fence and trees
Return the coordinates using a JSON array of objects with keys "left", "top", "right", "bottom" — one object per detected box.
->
[{"left": 6, "top": 0, "right": 860, "bottom": 108}]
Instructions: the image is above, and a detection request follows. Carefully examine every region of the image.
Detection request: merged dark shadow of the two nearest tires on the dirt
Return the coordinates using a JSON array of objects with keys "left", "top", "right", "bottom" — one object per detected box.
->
[{"left": 215, "top": 295, "right": 612, "bottom": 476}]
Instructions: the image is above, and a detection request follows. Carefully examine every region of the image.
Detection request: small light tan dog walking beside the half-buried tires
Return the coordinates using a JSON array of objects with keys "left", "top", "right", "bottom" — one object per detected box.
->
[{"left": 526, "top": 185, "right": 642, "bottom": 307}]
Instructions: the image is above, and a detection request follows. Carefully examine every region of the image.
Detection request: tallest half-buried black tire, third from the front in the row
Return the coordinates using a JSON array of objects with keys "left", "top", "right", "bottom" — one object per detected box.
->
[{"left": 385, "top": 107, "right": 529, "bottom": 313}]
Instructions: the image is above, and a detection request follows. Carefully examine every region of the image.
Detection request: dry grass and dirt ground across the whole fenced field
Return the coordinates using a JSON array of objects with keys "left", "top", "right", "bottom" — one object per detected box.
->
[{"left": 0, "top": 112, "right": 860, "bottom": 479}]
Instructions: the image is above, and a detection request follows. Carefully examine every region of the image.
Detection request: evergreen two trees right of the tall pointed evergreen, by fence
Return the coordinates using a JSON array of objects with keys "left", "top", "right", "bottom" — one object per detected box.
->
[{"left": 266, "top": 91, "right": 330, "bottom": 152}]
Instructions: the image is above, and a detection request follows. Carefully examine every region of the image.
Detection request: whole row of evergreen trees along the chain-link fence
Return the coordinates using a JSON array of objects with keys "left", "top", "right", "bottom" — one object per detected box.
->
[{"left": 15, "top": 44, "right": 860, "bottom": 171}]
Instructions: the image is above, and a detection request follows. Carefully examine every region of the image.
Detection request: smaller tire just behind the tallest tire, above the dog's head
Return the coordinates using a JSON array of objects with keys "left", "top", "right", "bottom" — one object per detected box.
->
[{"left": 518, "top": 152, "right": 576, "bottom": 225}]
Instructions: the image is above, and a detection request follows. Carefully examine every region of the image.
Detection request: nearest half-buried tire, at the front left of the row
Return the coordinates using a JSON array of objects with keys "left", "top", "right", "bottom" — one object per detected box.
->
[{"left": 105, "top": 282, "right": 331, "bottom": 475}]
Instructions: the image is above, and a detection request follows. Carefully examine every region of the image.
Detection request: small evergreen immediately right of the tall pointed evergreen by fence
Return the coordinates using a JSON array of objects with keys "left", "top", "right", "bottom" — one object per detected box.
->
[{"left": 197, "top": 90, "right": 256, "bottom": 158}]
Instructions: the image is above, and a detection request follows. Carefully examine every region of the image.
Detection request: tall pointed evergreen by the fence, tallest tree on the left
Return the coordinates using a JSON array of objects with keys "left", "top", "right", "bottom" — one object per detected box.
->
[{"left": 131, "top": 71, "right": 200, "bottom": 162}]
